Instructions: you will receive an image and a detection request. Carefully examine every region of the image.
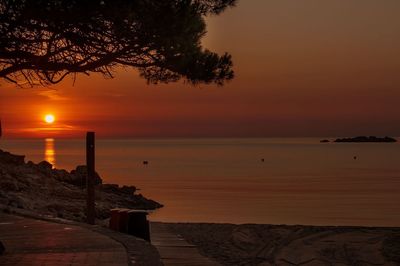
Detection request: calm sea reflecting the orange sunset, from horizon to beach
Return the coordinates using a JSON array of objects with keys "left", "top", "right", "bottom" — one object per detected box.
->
[{"left": 0, "top": 138, "right": 400, "bottom": 226}]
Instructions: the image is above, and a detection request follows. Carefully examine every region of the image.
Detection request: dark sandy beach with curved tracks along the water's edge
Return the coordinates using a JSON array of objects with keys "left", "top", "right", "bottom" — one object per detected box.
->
[{"left": 168, "top": 223, "right": 400, "bottom": 266}]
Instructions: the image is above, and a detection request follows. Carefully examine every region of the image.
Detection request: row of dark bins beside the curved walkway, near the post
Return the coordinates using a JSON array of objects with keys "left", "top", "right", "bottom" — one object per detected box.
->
[{"left": 110, "top": 209, "right": 150, "bottom": 242}]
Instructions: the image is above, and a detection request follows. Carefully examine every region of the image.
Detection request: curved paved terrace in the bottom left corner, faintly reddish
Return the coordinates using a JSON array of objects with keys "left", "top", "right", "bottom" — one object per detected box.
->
[{"left": 0, "top": 213, "right": 128, "bottom": 266}]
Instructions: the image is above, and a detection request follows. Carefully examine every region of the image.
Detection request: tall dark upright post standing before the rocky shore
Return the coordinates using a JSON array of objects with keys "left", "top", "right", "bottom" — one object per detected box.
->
[{"left": 86, "top": 132, "right": 96, "bottom": 224}]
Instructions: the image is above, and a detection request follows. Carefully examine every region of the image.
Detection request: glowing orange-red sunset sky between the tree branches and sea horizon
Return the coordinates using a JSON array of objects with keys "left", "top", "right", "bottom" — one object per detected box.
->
[{"left": 0, "top": 0, "right": 400, "bottom": 138}]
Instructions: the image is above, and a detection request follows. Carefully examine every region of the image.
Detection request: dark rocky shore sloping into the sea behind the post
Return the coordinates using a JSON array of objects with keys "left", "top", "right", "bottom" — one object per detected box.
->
[{"left": 0, "top": 150, "right": 162, "bottom": 223}]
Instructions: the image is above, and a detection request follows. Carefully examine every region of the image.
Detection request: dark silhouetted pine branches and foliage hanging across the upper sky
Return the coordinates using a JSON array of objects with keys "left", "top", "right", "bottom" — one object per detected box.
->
[{"left": 0, "top": 0, "right": 235, "bottom": 85}]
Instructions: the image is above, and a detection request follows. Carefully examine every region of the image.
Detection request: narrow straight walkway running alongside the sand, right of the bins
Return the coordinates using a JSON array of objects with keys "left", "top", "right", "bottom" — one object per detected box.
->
[{"left": 151, "top": 223, "right": 220, "bottom": 266}]
